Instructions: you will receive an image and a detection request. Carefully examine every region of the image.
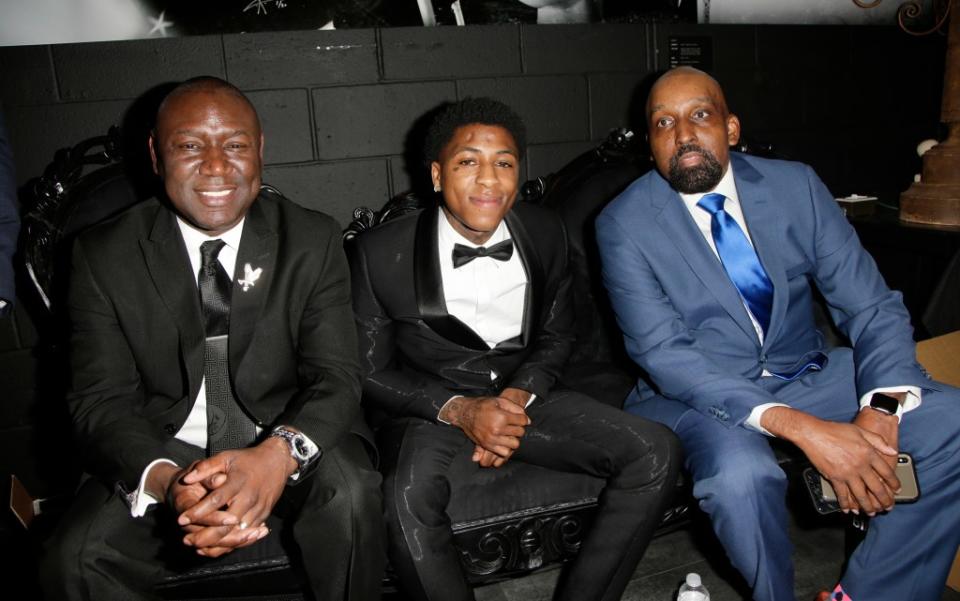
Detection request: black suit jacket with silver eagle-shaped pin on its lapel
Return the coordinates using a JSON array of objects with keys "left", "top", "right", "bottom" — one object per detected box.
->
[{"left": 68, "top": 190, "right": 362, "bottom": 488}]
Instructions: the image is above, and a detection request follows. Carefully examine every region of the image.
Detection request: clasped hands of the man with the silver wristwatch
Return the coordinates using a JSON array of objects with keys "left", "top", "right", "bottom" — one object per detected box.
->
[{"left": 167, "top": 438, "right": 296, "bottom": 557}]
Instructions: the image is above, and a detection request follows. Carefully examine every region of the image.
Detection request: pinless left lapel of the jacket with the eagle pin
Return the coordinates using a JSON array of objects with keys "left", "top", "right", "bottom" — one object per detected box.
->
[{"left": 140, "top": 208, "right": 204, "bottom": 399}]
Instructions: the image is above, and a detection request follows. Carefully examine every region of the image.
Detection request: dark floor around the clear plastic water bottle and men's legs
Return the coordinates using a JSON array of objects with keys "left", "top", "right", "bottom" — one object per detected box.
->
[{"left": 468, "top": 508, "right": 960, "bottom": 601}]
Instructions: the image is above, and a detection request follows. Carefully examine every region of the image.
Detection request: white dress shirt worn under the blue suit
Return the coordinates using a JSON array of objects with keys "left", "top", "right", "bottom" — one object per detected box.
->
[{"left": 680, "top": 163, "right": 920, "bottom": 436}]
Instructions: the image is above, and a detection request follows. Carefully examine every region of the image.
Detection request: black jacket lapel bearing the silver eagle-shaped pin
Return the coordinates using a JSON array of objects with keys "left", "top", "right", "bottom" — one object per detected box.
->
[{"left": 230, "top": 200, "right": 277, "bottom": 378}]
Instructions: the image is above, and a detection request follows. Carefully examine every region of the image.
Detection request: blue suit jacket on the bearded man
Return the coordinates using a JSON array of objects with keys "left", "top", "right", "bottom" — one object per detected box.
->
[{"left": 597, "top": 153, "right": 932, "bottom": 426}]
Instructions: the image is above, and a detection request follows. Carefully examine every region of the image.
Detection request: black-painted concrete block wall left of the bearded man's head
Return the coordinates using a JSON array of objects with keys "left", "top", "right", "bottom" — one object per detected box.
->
[{"left": 0, "top": 25, "right": 655, "bottom": 230}]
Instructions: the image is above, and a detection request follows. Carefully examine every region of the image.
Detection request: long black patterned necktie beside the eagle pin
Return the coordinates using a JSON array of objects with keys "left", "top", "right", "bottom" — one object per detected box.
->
[{"left": 197, "top": 239, "right": 257, "bottom": 455}]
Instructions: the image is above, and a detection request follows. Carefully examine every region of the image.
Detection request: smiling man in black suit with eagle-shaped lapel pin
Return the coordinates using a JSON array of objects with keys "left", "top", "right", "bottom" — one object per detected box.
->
[{"left": 44, "top": 77, "right": 384, "bottom": 600}]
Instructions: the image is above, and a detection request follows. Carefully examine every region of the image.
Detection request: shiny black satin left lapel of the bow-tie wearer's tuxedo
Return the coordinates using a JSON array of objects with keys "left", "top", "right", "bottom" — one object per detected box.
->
[{"left": 413, "top": 209, "right": 490, "bottom": 350}]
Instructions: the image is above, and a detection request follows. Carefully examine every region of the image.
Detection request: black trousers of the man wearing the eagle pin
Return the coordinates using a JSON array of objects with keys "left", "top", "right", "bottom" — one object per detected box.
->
[{"left": 41, "top": 434, "right": 386, "bottom": 601}]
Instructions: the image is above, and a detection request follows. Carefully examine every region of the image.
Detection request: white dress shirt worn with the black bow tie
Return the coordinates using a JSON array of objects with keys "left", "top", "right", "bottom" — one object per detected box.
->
[{"left": 437, "top": 208, "right": 536, "bottom": 413}]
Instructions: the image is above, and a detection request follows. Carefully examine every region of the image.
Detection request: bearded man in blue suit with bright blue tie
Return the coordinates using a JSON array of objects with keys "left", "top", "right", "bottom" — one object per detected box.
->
[{"left": 597, "top": 68, "right": 960, "bottom": 601}]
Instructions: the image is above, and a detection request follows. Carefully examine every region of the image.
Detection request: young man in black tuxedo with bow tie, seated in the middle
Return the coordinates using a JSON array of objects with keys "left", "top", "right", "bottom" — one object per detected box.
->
[{"left": 350, "top": 98, "right": 679, "bottom": 601}]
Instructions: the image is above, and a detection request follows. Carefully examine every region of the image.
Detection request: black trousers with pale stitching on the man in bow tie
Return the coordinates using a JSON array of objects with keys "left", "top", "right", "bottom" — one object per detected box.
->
[{"left": 378, "top": 391, "right": 681, "bottom": 601}]
